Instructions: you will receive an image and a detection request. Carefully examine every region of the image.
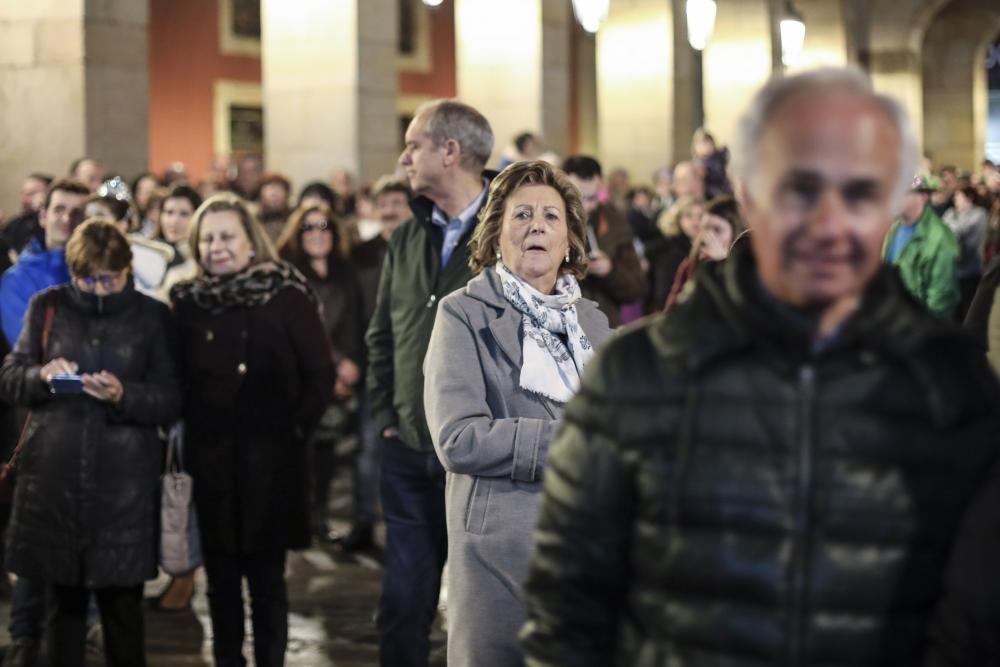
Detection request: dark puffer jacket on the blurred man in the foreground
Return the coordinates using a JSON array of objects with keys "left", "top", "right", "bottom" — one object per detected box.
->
[{"left": 523, "top": 248, "right": 1000, "bottom": 667}]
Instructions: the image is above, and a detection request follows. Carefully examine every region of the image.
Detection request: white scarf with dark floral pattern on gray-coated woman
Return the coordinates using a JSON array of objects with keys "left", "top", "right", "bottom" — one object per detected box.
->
[{"left": 496, "top": 262, "right": 594, "bottom": 403}]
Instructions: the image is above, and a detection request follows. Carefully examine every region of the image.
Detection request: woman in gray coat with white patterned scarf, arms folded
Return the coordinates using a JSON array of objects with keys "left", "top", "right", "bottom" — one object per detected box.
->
[{"left": 424, "top": 162, "right": 611, "bottom": 667}]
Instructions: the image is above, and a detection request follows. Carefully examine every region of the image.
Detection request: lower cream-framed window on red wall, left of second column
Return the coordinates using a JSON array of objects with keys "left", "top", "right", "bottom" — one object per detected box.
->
[{"left": 213, "top": 79, "right": 264, "bottom": 155}]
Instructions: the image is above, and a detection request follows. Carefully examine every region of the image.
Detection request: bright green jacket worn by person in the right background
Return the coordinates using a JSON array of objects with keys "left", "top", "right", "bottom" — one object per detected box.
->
[{"left": 882, "top": 206, "right": 961, "bottom": 319}]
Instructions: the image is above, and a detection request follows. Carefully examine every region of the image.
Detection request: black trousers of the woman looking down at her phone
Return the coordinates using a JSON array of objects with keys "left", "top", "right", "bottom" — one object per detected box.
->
[{"left": 48, "top": 584, "right": 146, "bottom": 667}]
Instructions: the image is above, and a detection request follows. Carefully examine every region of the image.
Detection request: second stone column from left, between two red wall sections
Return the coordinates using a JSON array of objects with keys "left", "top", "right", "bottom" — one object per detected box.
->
[{"left": 261, "top": 0, "right": 400, "bottom": 187}]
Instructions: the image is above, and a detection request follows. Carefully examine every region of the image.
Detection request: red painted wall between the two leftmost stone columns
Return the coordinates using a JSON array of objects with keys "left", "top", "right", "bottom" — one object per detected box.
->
[{"left": 149, "top": 0, "right": 260, "bottom": 180}]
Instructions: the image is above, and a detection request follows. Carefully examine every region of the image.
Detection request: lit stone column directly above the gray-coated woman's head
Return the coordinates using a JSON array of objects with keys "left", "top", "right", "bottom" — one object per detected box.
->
[{"left": 455, "top": 0, "right": 573, "bottom": 163}]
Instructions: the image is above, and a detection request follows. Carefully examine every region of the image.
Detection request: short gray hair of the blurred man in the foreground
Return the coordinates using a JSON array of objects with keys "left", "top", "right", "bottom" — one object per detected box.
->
[{"left": 731, "top": 67, "right": 920, "bottom": 210}]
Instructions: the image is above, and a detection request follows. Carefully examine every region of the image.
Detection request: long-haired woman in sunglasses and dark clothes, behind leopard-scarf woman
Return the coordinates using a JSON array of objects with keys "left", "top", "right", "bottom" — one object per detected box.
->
[{"left": 278, "top": 204, "right": 365, "bottom": 540}]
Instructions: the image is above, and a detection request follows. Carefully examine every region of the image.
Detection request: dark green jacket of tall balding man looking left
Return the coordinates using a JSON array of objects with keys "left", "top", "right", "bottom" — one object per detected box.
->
[{"left": 365, "top": 185, "right": 486, "bottom": 452}]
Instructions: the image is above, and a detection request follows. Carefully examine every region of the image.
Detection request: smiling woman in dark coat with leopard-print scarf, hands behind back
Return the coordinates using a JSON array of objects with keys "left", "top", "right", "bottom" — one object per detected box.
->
[{"left": 170, "top": 193, "right": 333, "bottom": 667}]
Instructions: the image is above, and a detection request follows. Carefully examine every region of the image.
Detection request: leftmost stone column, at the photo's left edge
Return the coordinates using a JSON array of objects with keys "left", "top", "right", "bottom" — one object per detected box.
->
[{"left": 0, "top": 0, "right": 149, "bottom": 213}]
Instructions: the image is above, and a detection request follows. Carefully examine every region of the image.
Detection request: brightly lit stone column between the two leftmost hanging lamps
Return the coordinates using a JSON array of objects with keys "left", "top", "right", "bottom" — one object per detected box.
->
[{"left": 597, "top": 0, "right": 691, "bottom": 182}]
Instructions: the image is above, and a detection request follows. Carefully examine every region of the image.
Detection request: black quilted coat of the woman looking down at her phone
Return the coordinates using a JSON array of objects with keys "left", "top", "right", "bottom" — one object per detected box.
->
[{"left": 0, "top": 284, "right": 181, "bottom": 588}]
